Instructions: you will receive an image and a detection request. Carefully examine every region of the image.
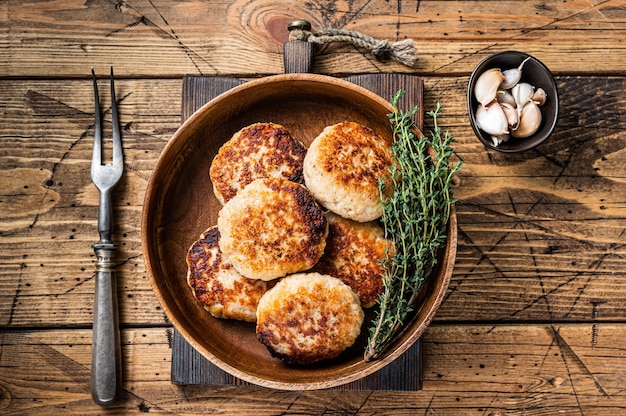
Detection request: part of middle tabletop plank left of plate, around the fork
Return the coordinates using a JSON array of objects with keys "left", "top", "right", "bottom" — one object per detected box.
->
[{"left": 0, "top": 79, "right": 181, "bottom": 326}]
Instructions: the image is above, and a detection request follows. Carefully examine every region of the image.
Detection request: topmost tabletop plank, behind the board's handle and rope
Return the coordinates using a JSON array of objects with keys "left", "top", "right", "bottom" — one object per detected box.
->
[{"left": 0, "top": 0, "right": 626, "bottom": 78}]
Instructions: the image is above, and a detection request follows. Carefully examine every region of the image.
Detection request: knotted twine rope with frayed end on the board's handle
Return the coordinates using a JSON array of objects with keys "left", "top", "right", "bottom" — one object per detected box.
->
[{"left": 289, "top": 28, "right": 417, "bottom": 67}]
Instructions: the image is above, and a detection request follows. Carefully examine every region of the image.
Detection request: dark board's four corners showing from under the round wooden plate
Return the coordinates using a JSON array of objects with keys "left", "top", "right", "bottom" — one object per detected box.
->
[{"left": 171, "top": 69, "right": 424, "bottom": 391}]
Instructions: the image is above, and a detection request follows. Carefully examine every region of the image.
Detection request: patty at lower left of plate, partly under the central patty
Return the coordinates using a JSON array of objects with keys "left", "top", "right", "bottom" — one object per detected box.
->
[{"left": 187, "top": 227, "right": 270, "bottom": 322}]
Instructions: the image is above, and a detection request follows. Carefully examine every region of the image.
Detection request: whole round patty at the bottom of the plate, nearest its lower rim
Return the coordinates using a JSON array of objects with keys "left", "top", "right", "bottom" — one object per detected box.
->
[{"left": 256, "top": 273, "right": 364, "bottom": 364}]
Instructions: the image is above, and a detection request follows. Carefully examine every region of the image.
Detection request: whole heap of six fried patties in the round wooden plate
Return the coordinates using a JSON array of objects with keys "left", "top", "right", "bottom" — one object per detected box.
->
[{"left": 187, "top": 122, "right": 393, "bottom": 364}]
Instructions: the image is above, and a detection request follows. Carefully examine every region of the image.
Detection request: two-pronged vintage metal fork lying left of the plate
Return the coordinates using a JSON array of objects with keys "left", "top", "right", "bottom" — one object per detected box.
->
[{"left": 91, "top": 67, "right": 124, "bottom": 406}]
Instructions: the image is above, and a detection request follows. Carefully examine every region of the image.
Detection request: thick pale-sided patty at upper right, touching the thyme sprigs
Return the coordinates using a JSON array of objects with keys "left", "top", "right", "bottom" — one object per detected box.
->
[{"left": 304, "top": 121, "right": 393, "bottom": 222}]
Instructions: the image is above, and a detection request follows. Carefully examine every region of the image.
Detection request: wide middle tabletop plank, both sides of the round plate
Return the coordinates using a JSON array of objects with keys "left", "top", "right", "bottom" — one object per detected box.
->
[{"left": 0, "top": 77, "right": 626, "bottom": 327}]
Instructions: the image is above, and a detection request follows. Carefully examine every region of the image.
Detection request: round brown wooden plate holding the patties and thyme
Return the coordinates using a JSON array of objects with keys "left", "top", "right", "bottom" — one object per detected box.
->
[{"left": 142, "top": 74, "right": 457, "bottom": 390}]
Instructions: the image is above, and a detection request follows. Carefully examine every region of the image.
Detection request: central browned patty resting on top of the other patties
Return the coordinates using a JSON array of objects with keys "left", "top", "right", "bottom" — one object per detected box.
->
[{"left": 217, "top": 178, "right": 328, "bottom": 280}]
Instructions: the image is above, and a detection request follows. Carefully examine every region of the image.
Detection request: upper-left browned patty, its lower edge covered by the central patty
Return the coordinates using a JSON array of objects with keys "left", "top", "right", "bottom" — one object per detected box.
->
[{"left": 209, "top": 123, "right": 306, "bottom": 204}]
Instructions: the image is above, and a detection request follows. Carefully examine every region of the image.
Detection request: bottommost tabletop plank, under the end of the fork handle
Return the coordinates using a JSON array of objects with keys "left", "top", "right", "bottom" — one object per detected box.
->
[{"left": 0, "top": 324, "right": 626, "bottom": 416}]
